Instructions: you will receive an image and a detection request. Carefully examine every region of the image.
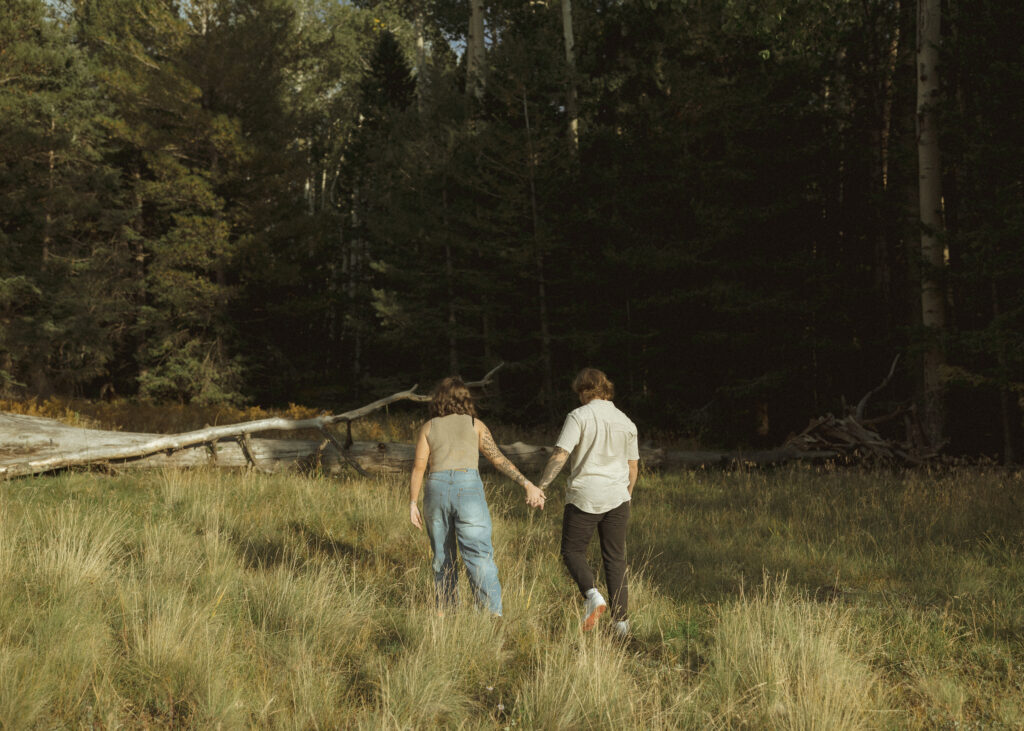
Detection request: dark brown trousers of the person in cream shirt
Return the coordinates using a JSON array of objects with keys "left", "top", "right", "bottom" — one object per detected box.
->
[{"left": 562, "top": 501, "right": 630, "bottom": 621}]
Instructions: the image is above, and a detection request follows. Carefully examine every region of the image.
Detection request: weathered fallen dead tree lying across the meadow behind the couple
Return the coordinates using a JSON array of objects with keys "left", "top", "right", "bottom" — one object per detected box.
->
[{"left": 0, "top": 352, "right": 923, "bottom": 479}]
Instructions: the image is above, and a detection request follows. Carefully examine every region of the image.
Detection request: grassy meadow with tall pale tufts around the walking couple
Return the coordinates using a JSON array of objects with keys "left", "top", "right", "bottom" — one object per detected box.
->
[{"left": 0, "top": 458, "right": 1024, "bottom": 729}]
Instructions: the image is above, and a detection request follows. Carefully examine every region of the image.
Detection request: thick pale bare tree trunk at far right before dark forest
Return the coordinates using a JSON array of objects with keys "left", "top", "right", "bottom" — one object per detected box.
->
[{"left": 918, "top": 0, "right": 946, "bottom": 446}]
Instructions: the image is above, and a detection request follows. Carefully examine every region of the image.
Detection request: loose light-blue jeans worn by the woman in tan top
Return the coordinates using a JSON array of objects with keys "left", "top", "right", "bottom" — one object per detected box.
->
[{"left": 423, "top": 470, "right": 502, "bottom": 614}]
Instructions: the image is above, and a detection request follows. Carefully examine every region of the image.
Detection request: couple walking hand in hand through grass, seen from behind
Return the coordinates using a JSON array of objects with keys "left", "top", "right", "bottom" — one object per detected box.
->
[{"left": 409, "top": 368, "right": 640, "bottom": 636}]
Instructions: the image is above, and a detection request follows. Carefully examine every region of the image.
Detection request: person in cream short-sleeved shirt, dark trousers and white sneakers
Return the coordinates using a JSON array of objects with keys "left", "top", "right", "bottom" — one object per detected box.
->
[{"left": 538, "top": 368, "right": 640, "bottom": 637}]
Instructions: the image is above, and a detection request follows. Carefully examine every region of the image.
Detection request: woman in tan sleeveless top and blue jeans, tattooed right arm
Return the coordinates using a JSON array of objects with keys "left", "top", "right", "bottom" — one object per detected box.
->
[{"left": 409, "top": 377, "right": 544, "bottom": 616}]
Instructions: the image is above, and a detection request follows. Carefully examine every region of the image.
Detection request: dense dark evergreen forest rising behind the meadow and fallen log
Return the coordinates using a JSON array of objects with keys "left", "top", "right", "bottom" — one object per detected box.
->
[{"left": 0, "top": 0, "right": 1024, "bottom": 459}]
